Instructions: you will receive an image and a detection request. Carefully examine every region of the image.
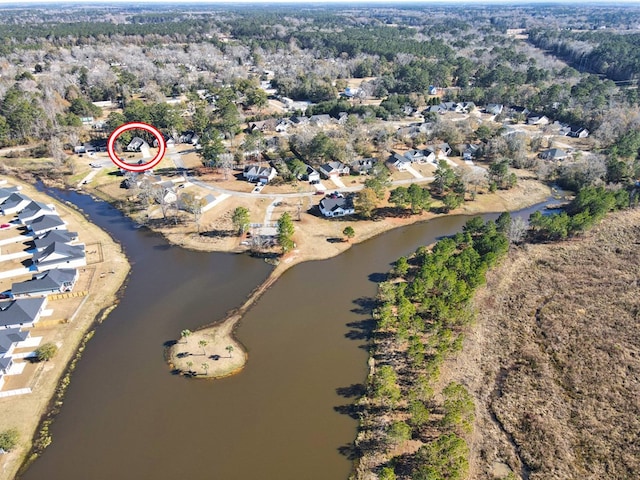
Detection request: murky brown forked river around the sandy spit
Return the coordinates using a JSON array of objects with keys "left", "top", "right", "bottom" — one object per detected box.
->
[{"left": 22, "top": 188, "right": 552, "bottom": 480}]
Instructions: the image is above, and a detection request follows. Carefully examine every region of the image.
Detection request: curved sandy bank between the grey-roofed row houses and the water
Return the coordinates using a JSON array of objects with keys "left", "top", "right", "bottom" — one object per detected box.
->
[{"left": 0, "top": 176, "right": 130, "bottom": 480}]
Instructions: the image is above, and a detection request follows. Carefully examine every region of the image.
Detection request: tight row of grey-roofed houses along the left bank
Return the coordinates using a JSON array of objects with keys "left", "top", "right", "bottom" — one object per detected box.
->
[{"left": 0, "top": 181, "right": 87, "bottom": 398}]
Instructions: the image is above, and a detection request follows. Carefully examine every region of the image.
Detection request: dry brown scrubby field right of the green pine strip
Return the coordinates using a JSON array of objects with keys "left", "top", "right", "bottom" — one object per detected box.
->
[{"left": 448, "top": 210, "right": 640, "bottom": 480}]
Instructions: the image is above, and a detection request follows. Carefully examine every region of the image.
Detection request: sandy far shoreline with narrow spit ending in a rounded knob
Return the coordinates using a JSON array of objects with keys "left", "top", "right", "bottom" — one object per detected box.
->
[{"left": 168, "top": 179, "right": 551, "bottom": 378}]
